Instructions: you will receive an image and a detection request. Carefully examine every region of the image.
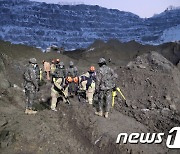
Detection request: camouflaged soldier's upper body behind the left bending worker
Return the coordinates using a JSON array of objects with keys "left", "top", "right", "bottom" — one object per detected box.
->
[{"left": 53, "top": 61, "right": 66, "bottom": 82}]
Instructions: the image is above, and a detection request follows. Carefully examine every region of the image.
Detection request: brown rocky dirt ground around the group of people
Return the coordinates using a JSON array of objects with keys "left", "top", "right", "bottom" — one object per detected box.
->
[{"left": 0, "top": 41, "right": 180, "bottom": 154}]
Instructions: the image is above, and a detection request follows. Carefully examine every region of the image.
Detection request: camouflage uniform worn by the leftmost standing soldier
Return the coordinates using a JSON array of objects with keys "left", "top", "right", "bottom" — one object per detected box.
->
[{"left": 24, "top": 64, "right": 38, "bottom": 109}]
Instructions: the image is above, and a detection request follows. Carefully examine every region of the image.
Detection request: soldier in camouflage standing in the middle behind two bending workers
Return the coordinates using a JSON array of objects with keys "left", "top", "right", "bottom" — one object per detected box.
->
[{"left": 67, "top": 61, "right": 78, "bottom": 96}]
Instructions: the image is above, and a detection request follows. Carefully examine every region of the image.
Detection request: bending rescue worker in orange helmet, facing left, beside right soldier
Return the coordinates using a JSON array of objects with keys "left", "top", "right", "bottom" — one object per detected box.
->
[{"left": 73, "top": 76, "right": 95, "bottom": 104}]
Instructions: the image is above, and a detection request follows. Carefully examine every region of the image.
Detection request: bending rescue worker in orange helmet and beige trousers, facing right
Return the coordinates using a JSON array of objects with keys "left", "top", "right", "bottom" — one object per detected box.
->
[{"left": 51, "top": 77, "right": 72, "bottom": 111}]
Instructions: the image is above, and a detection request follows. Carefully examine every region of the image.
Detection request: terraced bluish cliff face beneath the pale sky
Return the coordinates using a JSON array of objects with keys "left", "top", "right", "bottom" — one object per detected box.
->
[{"left": 0, "top": 0, "right": 180, "bottom": 49}]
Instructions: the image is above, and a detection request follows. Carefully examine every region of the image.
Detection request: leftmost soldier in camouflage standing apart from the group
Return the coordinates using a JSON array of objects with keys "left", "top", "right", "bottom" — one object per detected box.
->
[{"left": 24, "top": 58, "right": 39, "bottom": 114}]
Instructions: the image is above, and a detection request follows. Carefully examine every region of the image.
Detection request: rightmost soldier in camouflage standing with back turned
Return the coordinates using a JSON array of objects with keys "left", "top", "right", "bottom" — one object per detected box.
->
[{"left": 95, "top": 58, "right": 117, "bottom": 118}]
